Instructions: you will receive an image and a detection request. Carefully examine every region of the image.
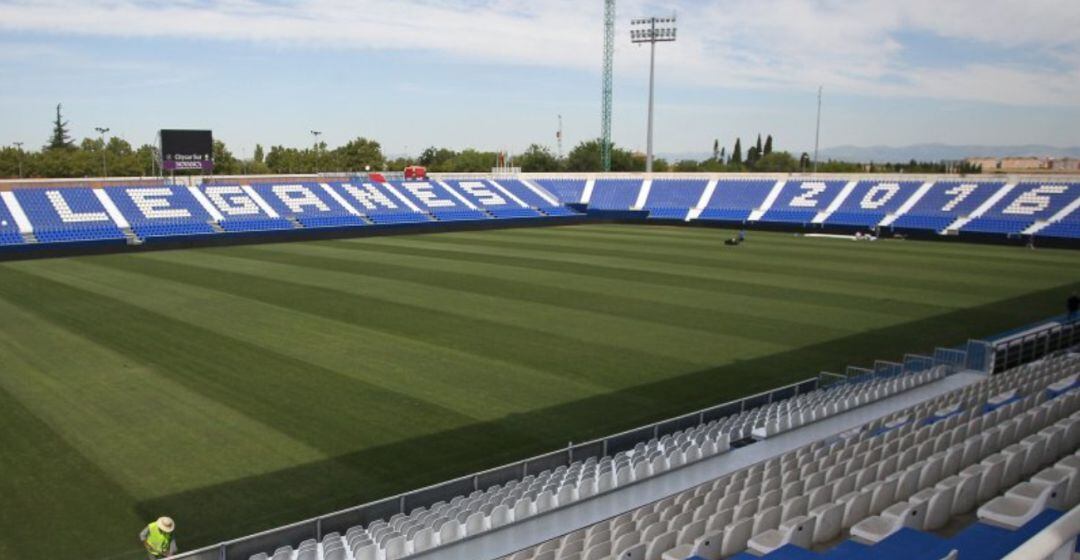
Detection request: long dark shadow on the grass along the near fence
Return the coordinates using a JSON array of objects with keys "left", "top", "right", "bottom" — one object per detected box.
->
[{"left": 133, "top": 284, "right": 1080, "bottom": 558}]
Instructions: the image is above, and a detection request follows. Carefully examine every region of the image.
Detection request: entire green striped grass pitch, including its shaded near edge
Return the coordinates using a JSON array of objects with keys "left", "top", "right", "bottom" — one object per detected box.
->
[{"left": 0, "top": 226, "right": 1080, "bottom": 559}]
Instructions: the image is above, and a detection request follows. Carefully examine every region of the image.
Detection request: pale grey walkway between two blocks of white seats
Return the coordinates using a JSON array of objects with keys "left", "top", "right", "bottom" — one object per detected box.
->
[{"left": 409, "top": 372, "right": 985, "bottom": 560}]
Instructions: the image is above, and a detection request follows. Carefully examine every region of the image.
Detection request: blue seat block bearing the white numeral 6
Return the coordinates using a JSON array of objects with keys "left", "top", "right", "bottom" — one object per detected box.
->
[{"left": 960, "top": 182, "right": 1080, "bottom": 233}]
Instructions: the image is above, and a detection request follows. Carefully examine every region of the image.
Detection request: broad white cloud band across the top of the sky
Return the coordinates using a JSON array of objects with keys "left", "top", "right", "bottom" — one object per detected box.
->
[{"left": 0, "top": 0, "right": 1080, "bottom": 107}]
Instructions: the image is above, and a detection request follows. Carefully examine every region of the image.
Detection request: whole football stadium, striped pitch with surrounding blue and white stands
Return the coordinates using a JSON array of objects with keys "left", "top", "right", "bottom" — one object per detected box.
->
[{"left": 0, "top": 0, "right": 1080, "bottom": 560}]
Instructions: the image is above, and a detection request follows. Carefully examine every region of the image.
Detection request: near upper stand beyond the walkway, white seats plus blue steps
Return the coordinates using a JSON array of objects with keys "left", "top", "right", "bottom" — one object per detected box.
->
[{"left": 505, "top": 354, "right": 1080, "bottom": 560}]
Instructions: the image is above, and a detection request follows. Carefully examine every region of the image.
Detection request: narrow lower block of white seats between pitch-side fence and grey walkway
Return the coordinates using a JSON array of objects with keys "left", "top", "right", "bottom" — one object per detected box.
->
[{"left": 240, "top": 366, "right": 976, "bottom": 560}]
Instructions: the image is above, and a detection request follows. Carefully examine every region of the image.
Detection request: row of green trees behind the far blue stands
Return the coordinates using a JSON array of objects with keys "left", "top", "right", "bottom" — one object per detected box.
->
[{"left": 0, "top": 105, "right": 980, "bottom": 178}]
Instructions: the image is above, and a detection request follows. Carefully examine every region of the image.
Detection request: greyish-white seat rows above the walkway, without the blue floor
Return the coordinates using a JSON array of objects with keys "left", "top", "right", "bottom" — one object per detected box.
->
[{"left": 509, "top": 356, "right": 1080, "bottom": 560}]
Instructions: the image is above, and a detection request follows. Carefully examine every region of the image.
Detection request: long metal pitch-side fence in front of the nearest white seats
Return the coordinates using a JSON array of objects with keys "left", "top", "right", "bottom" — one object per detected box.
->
[{"left": 175, "top": 378, "right": 819, "bottom": 560}]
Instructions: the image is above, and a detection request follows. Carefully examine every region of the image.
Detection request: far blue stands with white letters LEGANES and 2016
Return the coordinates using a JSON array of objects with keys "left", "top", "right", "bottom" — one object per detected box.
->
[{"left": 0, "top": 177, "right": 1080, "bottom": 252}]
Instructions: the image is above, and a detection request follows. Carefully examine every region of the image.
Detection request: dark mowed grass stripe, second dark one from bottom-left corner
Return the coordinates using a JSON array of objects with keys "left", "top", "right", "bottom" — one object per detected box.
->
[{"left": 0, "top": 268, "right": 486, "bottom": 454}]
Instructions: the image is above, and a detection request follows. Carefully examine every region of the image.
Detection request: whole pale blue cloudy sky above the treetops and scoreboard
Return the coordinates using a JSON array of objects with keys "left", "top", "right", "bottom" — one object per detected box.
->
[{"left": 0, "top": 0, "right": 1080, "bottom": 156}]
